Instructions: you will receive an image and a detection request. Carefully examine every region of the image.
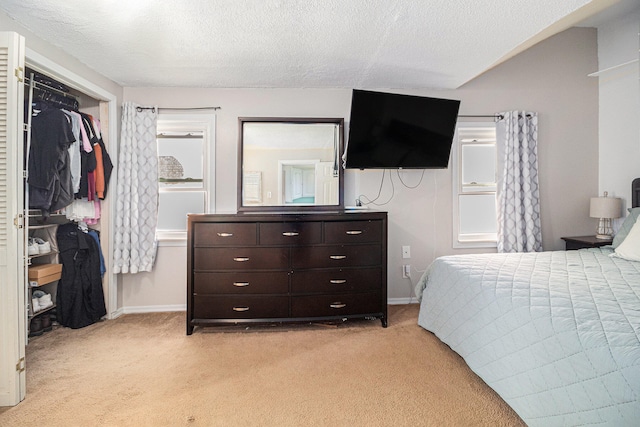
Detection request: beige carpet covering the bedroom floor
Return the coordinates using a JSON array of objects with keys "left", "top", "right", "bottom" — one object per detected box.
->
[{"left": 0, "top": 305, "right": 524, "bottom": 426}]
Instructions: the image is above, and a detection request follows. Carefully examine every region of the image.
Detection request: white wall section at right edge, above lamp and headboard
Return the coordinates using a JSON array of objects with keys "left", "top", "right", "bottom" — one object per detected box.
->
[{"left": 596, "top": 6, "right": 640, "bottom": 225}]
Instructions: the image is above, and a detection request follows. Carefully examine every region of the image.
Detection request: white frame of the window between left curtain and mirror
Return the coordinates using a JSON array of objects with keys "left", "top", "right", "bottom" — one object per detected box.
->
[{"left": 156, "top": 112, "right": 216, "bottom": 242}]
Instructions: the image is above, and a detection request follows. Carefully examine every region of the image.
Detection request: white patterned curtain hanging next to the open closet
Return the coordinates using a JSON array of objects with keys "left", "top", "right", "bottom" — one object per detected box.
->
[{"left": 113, "top": 102, "right": 158, "bottom": 273}]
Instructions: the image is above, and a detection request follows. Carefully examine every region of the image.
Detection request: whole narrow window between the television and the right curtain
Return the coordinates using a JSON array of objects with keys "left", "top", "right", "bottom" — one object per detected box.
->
[{"left": 452, "top": 122, "right": 498, "bottom": 248}]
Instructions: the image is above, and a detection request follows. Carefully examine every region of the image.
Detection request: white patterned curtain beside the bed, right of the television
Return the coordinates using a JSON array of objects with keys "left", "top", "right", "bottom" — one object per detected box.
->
[{"left": 496, "top": 111, "right": 542, "bottom": 252}]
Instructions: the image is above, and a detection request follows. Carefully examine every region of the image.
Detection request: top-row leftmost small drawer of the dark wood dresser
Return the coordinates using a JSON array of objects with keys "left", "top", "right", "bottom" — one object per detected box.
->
[{"left": 193, "top": 222, "right": 258, "bottom": 246}]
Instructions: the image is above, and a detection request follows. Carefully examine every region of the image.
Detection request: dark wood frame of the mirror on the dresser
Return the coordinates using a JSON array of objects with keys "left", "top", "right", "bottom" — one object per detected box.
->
[{"left": 237, "top": 117, "right": 344, "bottom": 212}]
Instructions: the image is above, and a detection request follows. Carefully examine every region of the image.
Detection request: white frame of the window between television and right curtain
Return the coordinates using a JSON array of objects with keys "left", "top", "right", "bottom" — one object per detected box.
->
[{"left": 451, "top": 122, "right": 499, "bottom": 249}]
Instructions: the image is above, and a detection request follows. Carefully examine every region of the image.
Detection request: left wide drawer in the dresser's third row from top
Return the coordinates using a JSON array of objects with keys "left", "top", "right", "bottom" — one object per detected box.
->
[{"left": 193, "top": 271, "right": 289, "bottom": 295}]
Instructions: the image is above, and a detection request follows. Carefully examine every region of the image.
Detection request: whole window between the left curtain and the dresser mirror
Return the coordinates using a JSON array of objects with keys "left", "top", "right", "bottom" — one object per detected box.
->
[{"left": 156, "top": 114, "right": 215, "bottom": 240}]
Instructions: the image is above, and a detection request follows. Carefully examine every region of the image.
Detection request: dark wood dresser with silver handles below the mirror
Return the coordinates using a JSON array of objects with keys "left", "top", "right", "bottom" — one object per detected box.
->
[{"left": 187, "top": 211, "right": 387, "bottom": 335}]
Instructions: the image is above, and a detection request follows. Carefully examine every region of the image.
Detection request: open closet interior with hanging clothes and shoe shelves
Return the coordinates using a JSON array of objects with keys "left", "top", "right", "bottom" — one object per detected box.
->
[{"left": 23, "top": 68, "right": 113, "bottom": 337}]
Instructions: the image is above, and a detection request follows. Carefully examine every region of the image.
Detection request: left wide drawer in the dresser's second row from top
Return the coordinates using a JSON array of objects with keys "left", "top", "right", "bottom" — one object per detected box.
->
[{"left": 193, "top": 247, "right": 289, "bottom": 271}]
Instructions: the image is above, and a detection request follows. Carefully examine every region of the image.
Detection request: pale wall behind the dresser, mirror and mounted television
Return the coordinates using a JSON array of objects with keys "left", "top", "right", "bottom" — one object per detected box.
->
[{"left": 122, "top": 28, "right": 598, "bottom": 307}]
